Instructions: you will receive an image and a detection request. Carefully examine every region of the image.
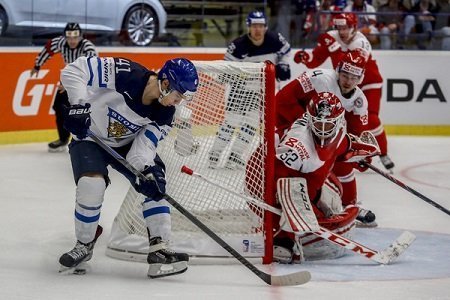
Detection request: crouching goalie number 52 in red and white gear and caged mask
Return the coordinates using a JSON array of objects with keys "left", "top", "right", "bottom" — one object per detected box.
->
[{"left": 246, "top": 92, "right": 379, "bottom": 263}]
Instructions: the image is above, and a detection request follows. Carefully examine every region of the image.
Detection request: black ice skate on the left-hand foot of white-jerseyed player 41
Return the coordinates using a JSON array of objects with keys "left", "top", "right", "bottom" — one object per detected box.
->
[{"left": 59, "top": 226, "right": 103, "bottom": 274}]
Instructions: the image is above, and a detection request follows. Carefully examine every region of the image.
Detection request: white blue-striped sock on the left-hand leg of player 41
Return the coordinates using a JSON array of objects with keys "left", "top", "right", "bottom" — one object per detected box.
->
[{"left": 75, "top": 176, "right": 106, "bottom": 243}]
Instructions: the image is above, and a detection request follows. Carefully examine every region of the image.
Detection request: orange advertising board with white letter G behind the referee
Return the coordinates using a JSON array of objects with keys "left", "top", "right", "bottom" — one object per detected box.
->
[{"left": 0, "top": 48, "right": 223, "bottom": 132}]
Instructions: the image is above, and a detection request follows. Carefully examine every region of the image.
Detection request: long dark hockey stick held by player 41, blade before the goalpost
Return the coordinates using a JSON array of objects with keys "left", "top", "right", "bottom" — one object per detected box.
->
[{"left": 88, "top": 129, "right": 311, "bottom": 286}]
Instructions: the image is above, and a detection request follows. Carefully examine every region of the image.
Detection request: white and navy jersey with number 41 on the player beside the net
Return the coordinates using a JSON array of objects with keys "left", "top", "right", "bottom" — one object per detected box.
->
[{"left": 61, "top": 57, "right": 175, "bottom": 170}]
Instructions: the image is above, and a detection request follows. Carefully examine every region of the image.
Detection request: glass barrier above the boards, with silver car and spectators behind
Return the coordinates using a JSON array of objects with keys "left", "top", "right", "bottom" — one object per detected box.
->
[{"left": 0, "top": 0, "right": 450, "bottom": 50}]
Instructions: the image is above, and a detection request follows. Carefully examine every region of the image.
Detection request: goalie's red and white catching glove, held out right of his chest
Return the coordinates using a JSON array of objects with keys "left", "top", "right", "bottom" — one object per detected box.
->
[{"left": 343, "top": 132, "right": 380, "bottom": 172}]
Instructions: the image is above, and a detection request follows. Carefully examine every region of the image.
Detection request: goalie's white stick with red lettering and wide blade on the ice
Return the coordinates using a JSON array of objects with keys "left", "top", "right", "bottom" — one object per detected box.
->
[{"left": 181, "top": 166, "right": 416, "bottom": 265}]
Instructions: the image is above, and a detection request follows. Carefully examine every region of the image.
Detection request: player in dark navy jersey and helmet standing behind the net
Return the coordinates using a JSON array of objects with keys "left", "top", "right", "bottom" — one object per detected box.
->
[{"left": 209, "top": 11, "right": 291, "bottom": 169}]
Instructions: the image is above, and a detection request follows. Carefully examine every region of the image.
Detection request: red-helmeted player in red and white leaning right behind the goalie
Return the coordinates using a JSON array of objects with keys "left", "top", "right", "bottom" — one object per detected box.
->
[{"left": 276, "top": 49, "right": 376, "bottom": 227}]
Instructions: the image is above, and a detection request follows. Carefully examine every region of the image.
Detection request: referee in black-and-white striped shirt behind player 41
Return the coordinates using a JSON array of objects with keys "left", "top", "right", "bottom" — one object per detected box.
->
[{"left": 30, "top": 23, "right": 97, "bottom": 152}]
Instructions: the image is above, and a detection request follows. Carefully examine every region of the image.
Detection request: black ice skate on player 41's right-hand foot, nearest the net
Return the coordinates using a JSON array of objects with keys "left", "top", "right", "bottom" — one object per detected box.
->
[{"left": 147, "top": 237, "right": 189, "bottom": 278}]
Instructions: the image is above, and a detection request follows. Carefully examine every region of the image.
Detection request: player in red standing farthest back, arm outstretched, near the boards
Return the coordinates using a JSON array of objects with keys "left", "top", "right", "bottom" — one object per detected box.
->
[{"left": 294, "top": 13, "right": 394, "bottom": 171}]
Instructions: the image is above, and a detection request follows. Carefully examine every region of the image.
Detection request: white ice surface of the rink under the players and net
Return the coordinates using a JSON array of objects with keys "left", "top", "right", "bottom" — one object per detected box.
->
[{"left": 0, "top": 137, "right": 450, "bottom": 300}]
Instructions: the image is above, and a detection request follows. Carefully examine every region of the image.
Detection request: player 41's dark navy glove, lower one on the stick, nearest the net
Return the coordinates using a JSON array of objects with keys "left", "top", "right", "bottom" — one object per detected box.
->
[{"left": 134, "top": 165, "right": 166, "bottom": 200}]
